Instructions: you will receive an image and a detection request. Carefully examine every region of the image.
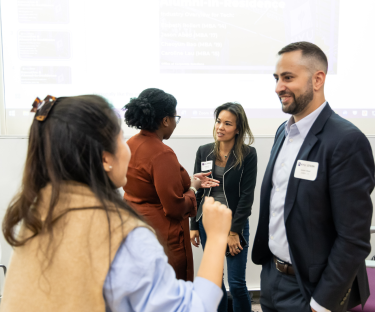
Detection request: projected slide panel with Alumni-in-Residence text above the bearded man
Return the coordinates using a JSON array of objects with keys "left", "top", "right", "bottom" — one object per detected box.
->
[{"left": 160, "top": 0, "right": 339, "bottom": 74}]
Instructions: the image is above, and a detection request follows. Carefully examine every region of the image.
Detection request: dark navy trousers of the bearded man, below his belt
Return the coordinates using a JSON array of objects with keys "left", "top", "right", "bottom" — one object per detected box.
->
[{"left": 260, "top": 259, "right": 311, "bottom": 312}]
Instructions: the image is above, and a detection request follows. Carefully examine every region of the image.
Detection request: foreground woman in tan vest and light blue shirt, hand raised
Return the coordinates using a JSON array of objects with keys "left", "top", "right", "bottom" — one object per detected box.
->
[{"left": 0, "top": 95, "right": 231, "bottom": 312}]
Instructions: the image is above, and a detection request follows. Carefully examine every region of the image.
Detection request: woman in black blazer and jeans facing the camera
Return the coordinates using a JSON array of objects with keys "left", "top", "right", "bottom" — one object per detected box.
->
[{"left": 190, "top": 103, "right": 257, "bottom": 312}]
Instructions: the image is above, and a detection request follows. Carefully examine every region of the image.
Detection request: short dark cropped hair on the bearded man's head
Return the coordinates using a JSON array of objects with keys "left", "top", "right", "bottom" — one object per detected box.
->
[{"left": 278, "top": 41, "right": 328, "bottom": 73}]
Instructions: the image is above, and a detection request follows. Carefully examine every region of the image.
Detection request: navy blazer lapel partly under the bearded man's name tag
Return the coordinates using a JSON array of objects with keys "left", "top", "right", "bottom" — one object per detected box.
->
[{"left": 284, "top": 103, "right": 333, "bottom": 223}]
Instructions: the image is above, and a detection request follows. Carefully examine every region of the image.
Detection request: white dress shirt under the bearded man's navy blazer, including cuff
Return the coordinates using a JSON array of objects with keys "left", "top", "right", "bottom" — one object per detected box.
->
[{"left": 268, "top": 102, "right": 329, "bottom": 312}]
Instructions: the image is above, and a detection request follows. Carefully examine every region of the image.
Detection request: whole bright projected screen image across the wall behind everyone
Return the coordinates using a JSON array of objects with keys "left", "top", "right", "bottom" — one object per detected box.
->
[{"left": 0, "top": 0, "right": 375, "bottom": 134}]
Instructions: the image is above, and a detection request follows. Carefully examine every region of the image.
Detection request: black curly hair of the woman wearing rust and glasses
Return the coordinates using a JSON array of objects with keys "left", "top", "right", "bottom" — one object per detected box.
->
[{"left": 124, "top": 88, "right": 177, "bottom": 132}]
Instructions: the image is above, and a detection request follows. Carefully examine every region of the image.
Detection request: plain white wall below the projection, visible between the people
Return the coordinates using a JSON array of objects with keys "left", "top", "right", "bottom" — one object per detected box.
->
[{"left": 0, "top": 136, "right": 375, "bottom": 289}]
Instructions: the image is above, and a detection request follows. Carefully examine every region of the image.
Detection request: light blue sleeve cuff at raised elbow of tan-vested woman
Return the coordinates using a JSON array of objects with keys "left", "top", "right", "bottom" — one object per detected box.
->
[{"left": 194, "top": 277, "right": 223, "bottom": 311}]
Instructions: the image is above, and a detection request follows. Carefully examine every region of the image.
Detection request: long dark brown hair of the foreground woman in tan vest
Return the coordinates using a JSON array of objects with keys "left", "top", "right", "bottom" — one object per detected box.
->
[{"left": 3, "top": 95, "right": 139, "bottom": 246}]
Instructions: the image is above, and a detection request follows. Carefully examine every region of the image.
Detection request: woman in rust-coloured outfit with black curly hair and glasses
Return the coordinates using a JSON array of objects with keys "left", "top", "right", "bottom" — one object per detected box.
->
[{"left": 124, "top": 88, "right": 216, "bottom": 281}]
